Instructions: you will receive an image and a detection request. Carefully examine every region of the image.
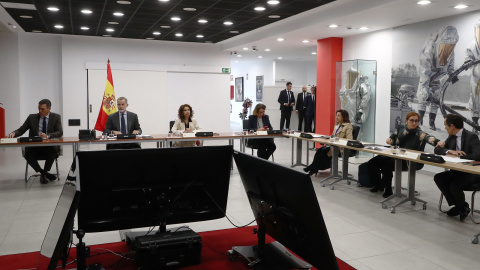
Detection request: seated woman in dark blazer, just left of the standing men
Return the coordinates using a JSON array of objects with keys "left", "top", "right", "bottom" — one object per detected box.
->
[{"left": 248, "top": 104, "right": 277, "bottom": 159}]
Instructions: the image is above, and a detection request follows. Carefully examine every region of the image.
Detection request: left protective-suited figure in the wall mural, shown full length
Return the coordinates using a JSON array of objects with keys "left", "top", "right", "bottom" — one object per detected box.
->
[{"left": 417, "top": 26, "right": 458, "bottom": 130}]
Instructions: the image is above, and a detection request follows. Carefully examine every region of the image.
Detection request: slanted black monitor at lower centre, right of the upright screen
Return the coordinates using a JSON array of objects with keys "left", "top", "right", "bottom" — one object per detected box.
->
[{"left": 233, "top": 152, "right": 338, "bottom": 269}]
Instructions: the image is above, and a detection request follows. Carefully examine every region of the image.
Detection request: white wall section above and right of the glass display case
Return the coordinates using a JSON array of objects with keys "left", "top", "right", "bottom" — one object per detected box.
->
[{"left": 343, "top": 29, "right": 392, "bottom": 143}]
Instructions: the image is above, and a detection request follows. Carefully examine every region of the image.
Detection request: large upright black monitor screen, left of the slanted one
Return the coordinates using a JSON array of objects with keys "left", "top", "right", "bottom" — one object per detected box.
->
[{"left": 77, "top": 145, "right": 233, "bottom": 232}]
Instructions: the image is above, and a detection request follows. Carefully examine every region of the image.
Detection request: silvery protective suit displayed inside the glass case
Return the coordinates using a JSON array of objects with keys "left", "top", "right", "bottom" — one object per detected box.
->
[{"left": 339, "top": 67, "right": 371, "bottom": 125}]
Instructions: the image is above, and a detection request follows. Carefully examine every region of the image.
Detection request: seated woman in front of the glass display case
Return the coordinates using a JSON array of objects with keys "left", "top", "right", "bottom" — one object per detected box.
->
[{"left": 303, "top": 110, "right": 353, "bottom": 175}]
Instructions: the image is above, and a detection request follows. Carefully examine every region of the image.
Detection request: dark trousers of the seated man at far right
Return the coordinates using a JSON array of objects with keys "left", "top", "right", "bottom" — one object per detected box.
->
[{"left": 433, "top": 170, "right": 480, "bottom": 207}]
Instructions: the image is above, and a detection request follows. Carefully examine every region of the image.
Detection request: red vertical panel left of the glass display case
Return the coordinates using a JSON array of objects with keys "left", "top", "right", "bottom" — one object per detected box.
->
[{"left": 315, "top": 37, "right": 343, "bottom": 135}]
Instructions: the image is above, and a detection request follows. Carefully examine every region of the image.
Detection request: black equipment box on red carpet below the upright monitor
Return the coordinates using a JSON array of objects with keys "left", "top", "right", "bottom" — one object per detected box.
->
[{"left": 127, "top": 230, "right": 202, "bottom": 269}]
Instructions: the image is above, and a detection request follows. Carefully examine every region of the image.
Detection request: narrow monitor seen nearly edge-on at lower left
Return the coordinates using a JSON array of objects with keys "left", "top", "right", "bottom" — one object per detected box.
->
[{"left": 37, "top": 181, "right": 80, "bottom": 270}]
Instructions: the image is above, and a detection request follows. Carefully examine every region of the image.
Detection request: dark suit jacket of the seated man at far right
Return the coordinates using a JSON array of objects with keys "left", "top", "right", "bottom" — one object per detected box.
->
[{"left": 435, "top": 129, "right": 480, "bottom": 160}]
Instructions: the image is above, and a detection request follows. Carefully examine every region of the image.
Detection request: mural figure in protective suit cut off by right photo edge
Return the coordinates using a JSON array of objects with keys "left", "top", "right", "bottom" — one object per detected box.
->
[{"left": 465, "top": 20, "right": 480, "bottom": 134}]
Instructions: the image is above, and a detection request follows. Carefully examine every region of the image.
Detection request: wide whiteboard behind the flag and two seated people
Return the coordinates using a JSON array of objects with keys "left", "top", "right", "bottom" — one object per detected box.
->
[{"left": 88, "top": 69, "right": 230, "bottom": 134}]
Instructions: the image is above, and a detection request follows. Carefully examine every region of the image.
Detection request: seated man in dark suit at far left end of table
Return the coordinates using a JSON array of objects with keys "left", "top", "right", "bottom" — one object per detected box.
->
[{"left": 7, "top": 99, "right": 63, "bottom": 184}]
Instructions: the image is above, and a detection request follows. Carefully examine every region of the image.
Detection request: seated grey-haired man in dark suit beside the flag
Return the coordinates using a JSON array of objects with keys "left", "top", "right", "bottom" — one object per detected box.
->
[{"left": 103, "top": 97, "right": 142, "bottom": 149}]
